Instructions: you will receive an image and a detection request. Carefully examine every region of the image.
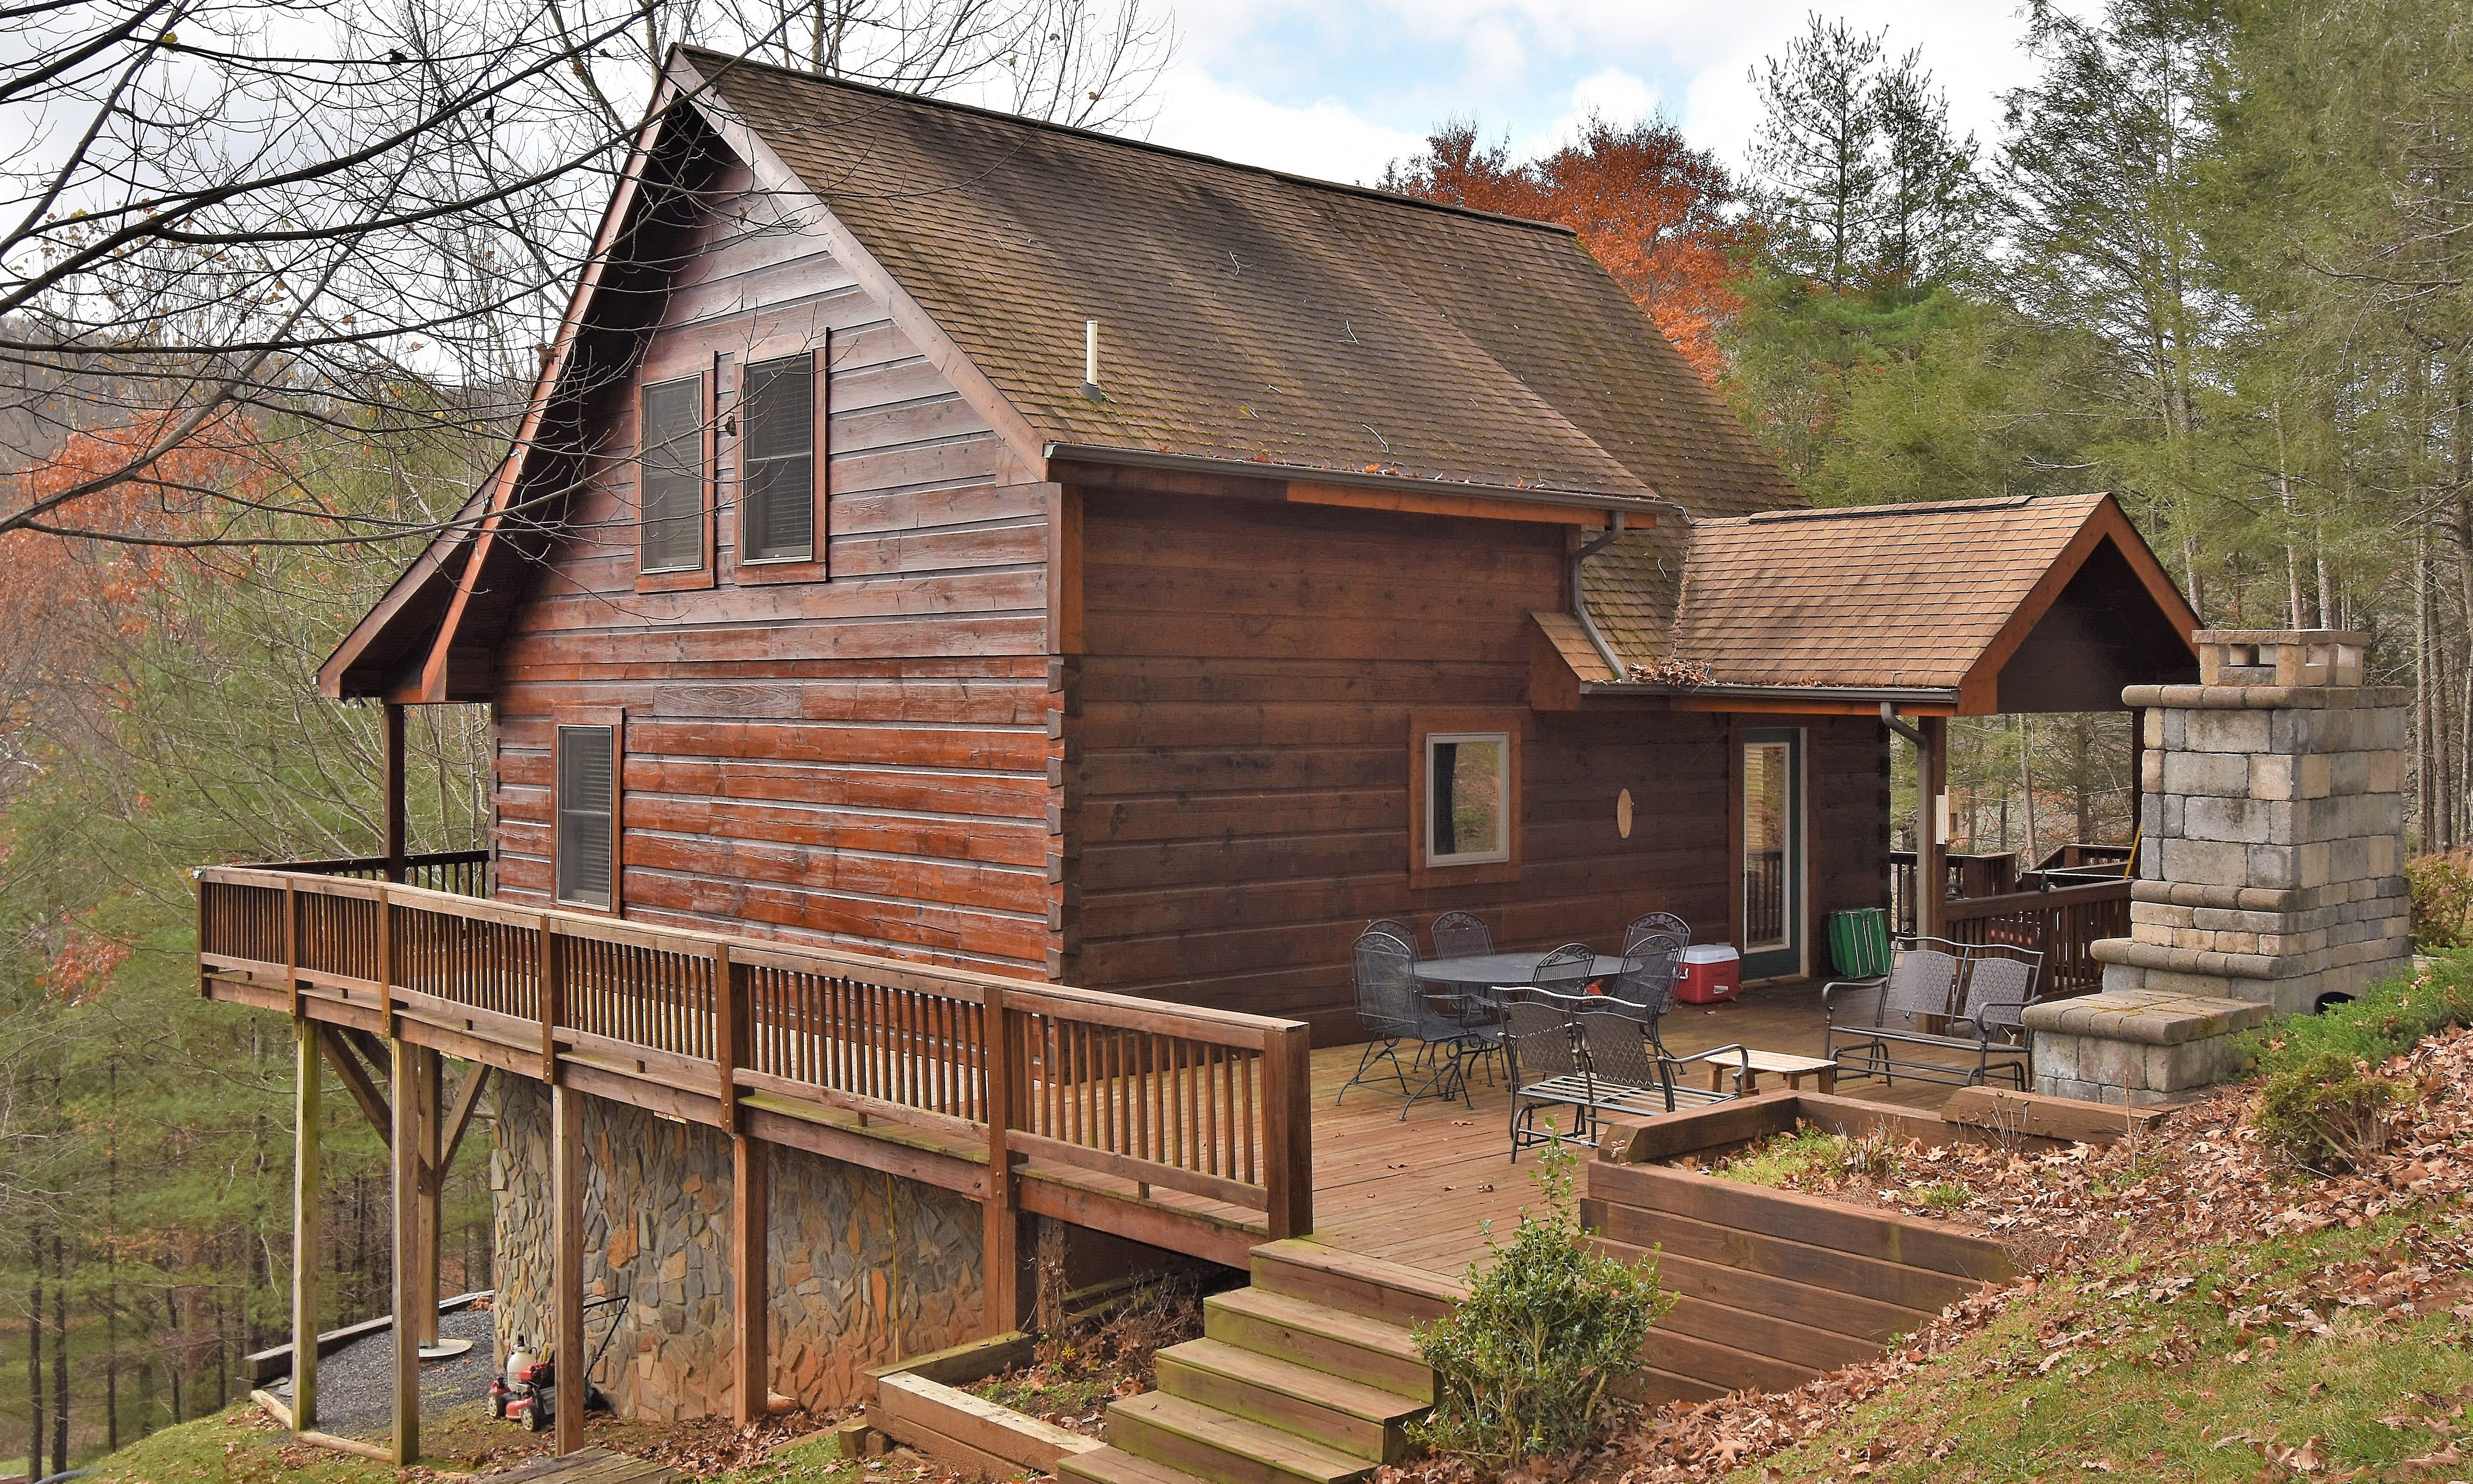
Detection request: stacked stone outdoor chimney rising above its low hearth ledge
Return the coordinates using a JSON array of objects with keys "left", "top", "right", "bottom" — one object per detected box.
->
[{"left": 2095, "top": 628, "right": 2411, "bottom": 1014}]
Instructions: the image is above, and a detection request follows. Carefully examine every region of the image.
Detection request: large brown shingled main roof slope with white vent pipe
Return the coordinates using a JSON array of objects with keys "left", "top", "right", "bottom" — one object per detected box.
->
[{"left": 680, "top": 49, "right": 1803, "bottom": 515}]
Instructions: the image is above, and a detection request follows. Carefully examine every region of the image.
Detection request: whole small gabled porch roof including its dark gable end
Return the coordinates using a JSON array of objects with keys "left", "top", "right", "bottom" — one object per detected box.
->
[{"left": 1538, "top": 495, "right": 2199, "bottom": 715}]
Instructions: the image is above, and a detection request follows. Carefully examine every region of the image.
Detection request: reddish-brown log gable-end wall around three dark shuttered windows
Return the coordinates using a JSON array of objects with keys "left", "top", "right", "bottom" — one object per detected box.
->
[{"left": 495, "top": 159, "right": 1053, "bottom": 975}]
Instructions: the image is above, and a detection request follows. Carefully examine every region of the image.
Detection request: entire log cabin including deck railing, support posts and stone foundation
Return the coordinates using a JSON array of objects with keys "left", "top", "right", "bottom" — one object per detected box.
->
[{"left": 200, "top": 49, "right": 2196, "bottom": 1462}]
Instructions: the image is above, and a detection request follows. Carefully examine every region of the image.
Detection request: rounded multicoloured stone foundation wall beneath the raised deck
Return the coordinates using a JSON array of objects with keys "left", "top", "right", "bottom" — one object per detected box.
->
[{"left": 490, "top": 1076, "right": 984, "bottom": 1422}]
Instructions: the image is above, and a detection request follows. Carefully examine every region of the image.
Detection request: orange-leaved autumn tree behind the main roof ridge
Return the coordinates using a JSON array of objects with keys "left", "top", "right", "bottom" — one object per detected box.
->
[{"left": 1382, "top": 116, "right": 1753, "bottom": 381}]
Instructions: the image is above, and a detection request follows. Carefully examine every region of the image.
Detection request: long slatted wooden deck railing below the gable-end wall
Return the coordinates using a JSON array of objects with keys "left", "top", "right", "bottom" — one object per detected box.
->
[{"left": 198, "top": 861, "right": 1313, "bottom": 1239}]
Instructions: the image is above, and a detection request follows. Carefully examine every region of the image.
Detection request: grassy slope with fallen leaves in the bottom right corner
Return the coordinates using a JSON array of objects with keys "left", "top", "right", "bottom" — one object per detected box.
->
[{"left": 1731, "top": 1217, "right": 2473, "bottom": 1484}]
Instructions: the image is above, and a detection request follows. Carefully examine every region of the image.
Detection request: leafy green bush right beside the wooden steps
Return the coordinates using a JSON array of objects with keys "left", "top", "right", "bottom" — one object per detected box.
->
[{"left": 1417, "top": 1145, "right": 1674, "bottom": 1464}]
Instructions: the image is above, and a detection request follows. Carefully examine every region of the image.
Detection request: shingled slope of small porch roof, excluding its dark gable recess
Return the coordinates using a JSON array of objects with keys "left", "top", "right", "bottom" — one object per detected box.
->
[{"left": 1560, "top": 495, "right": 2196, "bottom": 697}]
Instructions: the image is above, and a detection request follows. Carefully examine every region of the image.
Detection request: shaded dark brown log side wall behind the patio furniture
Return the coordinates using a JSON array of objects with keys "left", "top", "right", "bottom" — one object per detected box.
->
[{"left": 1066, "top": 490, "right": 1889, "bottom": 1044}]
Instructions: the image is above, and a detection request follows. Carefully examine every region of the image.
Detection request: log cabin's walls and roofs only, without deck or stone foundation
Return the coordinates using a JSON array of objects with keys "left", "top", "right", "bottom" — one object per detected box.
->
[{"left": 319, "top": 49, "right": 2196, "bottom": 1041}]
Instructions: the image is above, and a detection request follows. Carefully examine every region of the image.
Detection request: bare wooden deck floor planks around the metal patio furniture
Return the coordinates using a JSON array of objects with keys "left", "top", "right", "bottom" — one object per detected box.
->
[{"left": 1313, "top": 982, "right": 1954, "bottom": 1279}]
